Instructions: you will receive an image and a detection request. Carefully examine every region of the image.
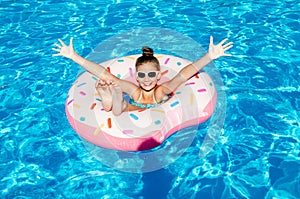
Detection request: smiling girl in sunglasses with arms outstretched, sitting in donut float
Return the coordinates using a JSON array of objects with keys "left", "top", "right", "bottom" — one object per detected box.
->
[{"left": 52, "top": 36, "right": 233, "bottom": 115}]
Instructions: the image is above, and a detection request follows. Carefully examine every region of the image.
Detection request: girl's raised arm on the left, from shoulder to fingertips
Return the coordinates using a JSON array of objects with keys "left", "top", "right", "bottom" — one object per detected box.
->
[{"left": 52, "top": 38, "right": 137, "bottom": 94}]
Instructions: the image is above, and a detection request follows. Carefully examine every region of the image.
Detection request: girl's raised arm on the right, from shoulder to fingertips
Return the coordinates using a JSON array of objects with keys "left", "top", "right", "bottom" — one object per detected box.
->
[{"left": 161, "top": 36, "right": 233, "bottom": 95}]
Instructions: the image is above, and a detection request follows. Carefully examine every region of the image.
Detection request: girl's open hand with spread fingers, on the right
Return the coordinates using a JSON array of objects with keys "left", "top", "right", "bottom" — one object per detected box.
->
[{"left": 208, "top": 36, "right": 233, "bottom": 60}]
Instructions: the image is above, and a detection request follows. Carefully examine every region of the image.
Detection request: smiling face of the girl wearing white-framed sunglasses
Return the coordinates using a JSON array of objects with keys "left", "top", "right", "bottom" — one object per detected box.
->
[{"left": 136, "top": 63, "right": 161, "bottom": 91}]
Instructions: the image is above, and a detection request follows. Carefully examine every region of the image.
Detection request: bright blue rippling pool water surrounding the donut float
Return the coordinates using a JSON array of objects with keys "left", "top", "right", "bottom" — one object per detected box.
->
[{"left": 0, "top": 0, "right": 300, "bottom": 199}]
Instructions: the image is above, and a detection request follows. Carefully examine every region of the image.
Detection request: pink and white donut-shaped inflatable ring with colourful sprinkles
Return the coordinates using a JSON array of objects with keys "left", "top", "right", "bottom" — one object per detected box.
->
[{"left": 65, "top": 54, "right": 216, "bottom": 151}]
